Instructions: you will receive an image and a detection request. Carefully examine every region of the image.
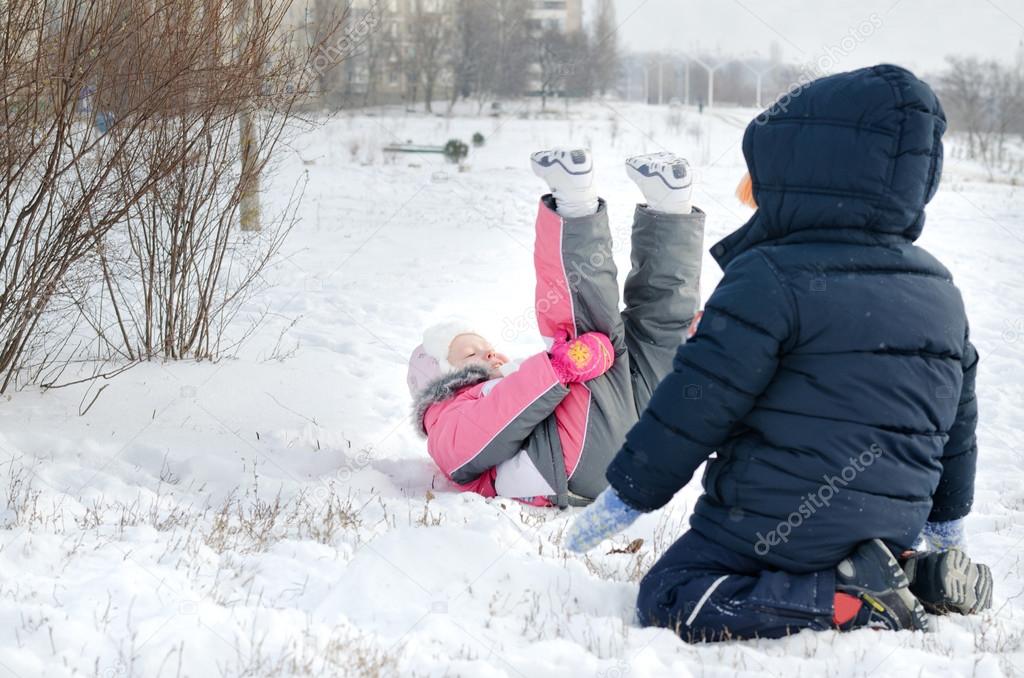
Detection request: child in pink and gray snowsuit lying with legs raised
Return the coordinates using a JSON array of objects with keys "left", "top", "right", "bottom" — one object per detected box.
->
[{"left": 409, "top": 150, "right": 705, "bottom": 507}]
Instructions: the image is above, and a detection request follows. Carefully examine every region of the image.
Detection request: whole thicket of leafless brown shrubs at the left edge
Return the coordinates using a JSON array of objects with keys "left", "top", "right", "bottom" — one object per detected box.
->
[{"left": 0, "top": 0, "right": 339, "bottom": 390}]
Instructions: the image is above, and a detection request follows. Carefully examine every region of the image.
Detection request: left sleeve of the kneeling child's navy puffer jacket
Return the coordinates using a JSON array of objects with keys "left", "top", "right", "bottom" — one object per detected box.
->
[{"left": 607, "top": 250, "right": 798, "bottom": 511}]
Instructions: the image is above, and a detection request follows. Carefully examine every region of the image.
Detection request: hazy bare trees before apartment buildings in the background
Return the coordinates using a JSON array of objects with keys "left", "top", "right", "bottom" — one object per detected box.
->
[{"left": 312, "top": 0, "right": 618, "bottom": 112}]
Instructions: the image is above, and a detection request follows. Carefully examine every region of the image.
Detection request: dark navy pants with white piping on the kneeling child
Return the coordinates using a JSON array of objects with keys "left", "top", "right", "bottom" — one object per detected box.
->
[{"left": 637, "top": 529, "right": 836, "bottom": 642}]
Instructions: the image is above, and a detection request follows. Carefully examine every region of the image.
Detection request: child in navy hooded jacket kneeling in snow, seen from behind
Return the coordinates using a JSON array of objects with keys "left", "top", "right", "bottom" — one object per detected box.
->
[{"left": 566, "top": 66, "right": 992, "bottom": 640}]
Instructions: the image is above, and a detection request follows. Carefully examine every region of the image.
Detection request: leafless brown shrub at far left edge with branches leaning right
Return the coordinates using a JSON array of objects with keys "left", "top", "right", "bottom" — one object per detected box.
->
[{"left": 0, "top": 0, "right": 190, "bottom": 390}]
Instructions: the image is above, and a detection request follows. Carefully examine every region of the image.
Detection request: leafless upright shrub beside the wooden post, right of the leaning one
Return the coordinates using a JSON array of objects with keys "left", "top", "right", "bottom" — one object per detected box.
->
[{"left": 82, "top": 0, "right": 335, "bottom": 359}]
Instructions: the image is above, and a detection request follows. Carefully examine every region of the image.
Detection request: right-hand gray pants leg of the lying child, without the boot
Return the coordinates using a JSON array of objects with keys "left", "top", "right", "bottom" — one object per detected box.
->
[{"left": 623, "top": 205, "right": 705, "bottom": 417}]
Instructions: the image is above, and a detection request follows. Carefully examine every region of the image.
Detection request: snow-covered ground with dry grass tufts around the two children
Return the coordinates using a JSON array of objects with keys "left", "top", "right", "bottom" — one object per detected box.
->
[{"left": 0, "top": 102, "right": 1024, "bottom": 678}]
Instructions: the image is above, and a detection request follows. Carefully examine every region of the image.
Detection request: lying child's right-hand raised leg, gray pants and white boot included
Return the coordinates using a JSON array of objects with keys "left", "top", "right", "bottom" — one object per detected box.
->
[{"left": 623, "top": 154, "right": 705, "bottom": 416}]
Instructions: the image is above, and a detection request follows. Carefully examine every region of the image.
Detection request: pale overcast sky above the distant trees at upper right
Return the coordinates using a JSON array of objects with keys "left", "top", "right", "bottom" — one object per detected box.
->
[{"left": 598, "top": 0, "right": 1024, "bottom": 73}]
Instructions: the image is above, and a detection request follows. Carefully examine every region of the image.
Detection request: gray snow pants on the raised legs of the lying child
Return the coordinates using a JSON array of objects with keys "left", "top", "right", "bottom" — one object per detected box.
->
[{"left": 538, "top": 196, "right": 703, "bottom": 498}]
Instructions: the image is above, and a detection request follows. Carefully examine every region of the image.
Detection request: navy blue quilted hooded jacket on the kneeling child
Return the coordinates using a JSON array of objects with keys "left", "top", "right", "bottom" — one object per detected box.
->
[{"left": 607, "top": 66, "right": 978, "bottom": 573}]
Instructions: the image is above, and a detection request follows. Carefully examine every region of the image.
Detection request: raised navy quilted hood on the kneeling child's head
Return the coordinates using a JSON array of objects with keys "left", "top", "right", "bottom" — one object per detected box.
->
[{"left": 711, "top": 65, "right": 946, "bottom": 267}]
